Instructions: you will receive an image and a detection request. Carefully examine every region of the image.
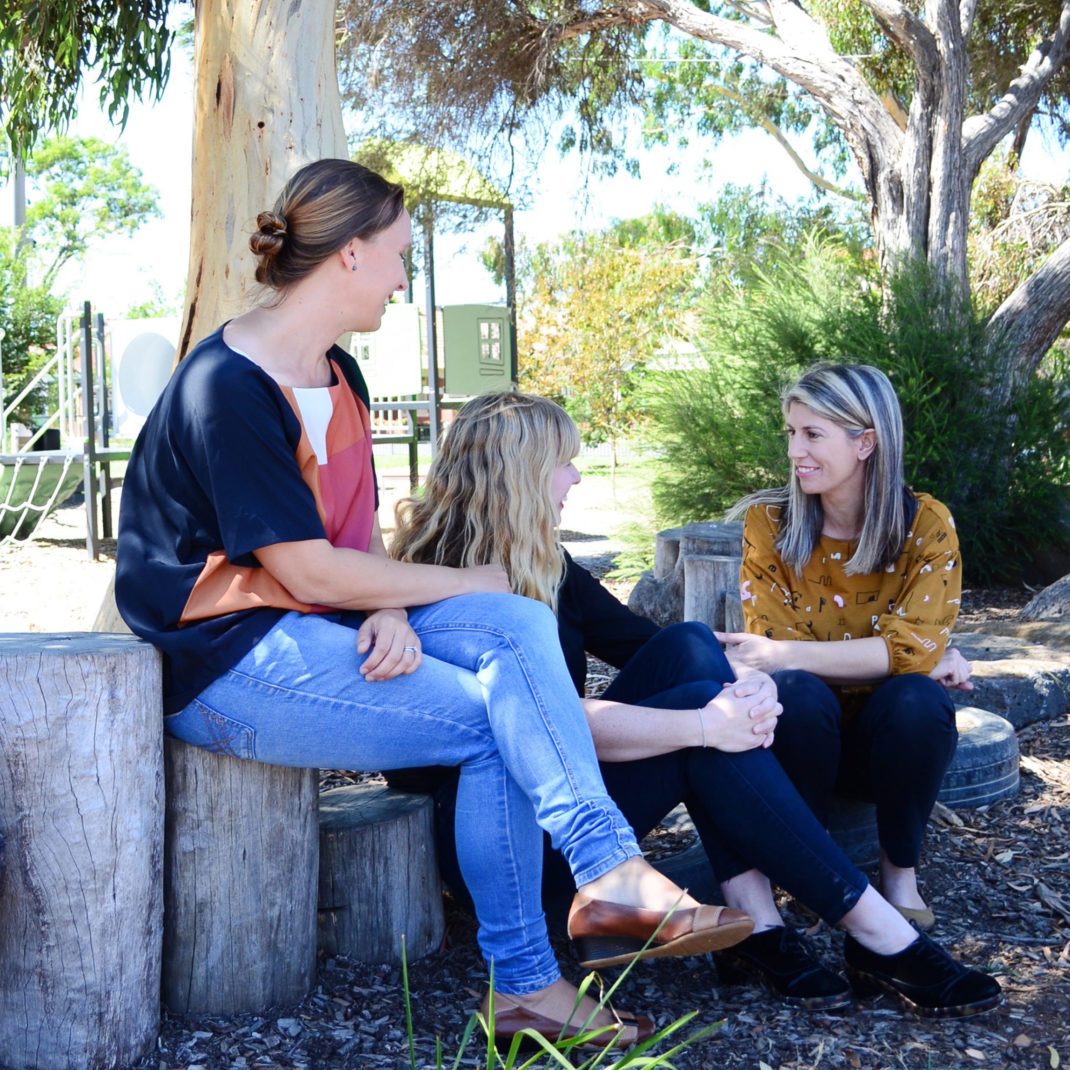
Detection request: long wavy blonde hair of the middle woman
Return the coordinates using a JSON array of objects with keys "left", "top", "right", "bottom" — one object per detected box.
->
[{"left": 391, "top": 393, "right": 580, "bottom": 611}]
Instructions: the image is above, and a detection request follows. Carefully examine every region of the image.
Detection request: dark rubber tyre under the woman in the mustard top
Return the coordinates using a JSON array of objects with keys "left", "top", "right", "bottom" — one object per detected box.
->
[{"left": 828, "top": 706, "right": 1019, "bottom": 867}]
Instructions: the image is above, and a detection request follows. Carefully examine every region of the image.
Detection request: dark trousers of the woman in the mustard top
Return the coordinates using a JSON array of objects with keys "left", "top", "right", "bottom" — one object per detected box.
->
[{"left": 773, "top": 670, "right": 959, "bottom": 869}]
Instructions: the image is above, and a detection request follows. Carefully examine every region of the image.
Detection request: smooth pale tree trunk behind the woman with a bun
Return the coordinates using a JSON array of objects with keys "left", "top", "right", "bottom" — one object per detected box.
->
[{"left": 179, "top": 0, "right": 348, "bottom": 360}]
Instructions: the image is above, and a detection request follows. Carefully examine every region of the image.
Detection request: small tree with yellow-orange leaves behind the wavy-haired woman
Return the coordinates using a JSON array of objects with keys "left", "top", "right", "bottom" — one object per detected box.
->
[{"left": 518, "top": 212, "right": 699, "bottom": 465}]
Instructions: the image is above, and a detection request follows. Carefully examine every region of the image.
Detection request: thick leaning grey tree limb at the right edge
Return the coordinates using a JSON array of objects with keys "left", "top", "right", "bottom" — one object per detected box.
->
[{"left": 988, "top": 238, "right": 1070, "bottom": 389}]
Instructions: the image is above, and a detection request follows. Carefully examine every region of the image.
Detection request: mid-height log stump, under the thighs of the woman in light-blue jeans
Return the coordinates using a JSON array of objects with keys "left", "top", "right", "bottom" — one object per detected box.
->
[{"left": 163, "top": 738, "right": 319, "bottom": 1014}]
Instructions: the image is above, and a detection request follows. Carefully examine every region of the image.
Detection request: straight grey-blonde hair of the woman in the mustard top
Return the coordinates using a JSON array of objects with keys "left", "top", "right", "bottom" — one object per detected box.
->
[{"left": 729, "top": 364, "right": 917, "bottom": 576}]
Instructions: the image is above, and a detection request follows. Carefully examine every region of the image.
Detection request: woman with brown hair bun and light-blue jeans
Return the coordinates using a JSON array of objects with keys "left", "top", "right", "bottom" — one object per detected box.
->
[{"left": 116, "top": 159, "right": 752, "bottom": 1042}]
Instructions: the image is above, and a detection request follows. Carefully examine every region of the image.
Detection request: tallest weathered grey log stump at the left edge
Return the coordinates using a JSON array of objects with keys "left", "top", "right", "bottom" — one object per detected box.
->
[{"left": 0, "top": 633, "right": 164, "bottom": 1070}]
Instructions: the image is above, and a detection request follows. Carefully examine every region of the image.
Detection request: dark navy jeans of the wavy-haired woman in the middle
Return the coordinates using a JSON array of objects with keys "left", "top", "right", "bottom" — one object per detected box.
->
[{"left": 435, "top": 622, "right": 868, "bottom": 924}]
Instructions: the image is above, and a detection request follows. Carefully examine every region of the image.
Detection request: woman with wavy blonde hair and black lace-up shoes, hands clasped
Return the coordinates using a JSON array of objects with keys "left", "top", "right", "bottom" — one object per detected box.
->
[{"left": 391, "top": 394, "right": 999, "bottom": 1017}]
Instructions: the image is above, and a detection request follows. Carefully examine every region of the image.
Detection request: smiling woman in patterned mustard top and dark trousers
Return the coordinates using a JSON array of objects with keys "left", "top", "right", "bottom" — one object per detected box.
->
[{"left": 723, "top": 364, "right": 973, "bottom": 931}]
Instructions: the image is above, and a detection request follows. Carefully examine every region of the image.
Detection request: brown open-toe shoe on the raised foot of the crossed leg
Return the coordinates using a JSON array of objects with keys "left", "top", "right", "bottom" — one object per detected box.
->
[{"left": 568, "top": 892, "right": 754, "bottom": 969}]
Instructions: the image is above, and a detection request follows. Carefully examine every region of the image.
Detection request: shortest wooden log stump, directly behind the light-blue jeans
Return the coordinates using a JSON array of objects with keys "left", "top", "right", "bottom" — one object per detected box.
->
[{"left": 319, "top": 784, "right": 445, "bottom": 962}]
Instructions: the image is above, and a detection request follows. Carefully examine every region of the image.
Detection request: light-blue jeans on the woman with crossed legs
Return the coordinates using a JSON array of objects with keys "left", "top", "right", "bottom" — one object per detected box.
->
[{"left": 166, "top": 595, "right": 639, "bottom": 994}]
